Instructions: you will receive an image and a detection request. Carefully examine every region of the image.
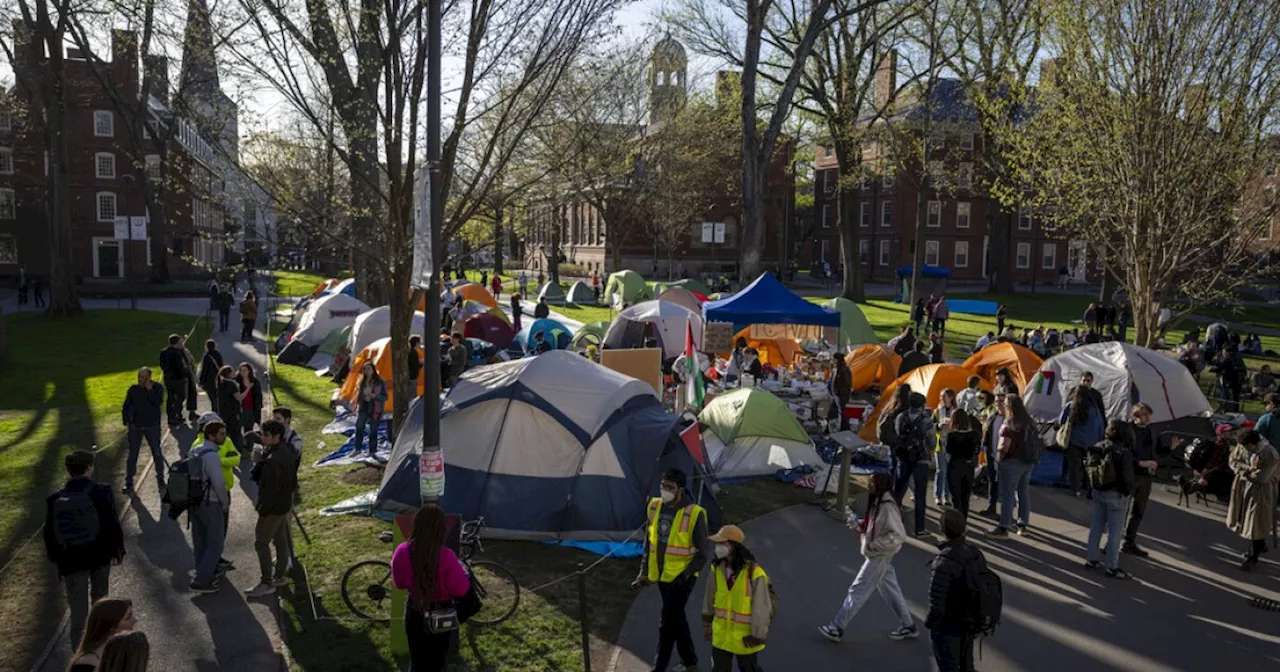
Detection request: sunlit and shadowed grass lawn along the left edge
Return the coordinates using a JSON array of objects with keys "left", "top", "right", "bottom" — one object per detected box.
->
[{"left": 0, "top": 310, "right": 207, "bottom": 669}]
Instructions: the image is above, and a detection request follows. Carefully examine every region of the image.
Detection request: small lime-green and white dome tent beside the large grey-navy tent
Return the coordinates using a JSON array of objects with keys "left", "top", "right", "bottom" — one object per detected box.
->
[{"left": 698, "top": 388, "right": 823, "bottom": 477}]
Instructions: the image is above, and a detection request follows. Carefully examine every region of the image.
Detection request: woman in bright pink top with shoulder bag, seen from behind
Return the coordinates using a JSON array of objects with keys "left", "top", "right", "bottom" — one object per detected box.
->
[{"left": 392, "top": 504, "right": 471, "bottom": 672}]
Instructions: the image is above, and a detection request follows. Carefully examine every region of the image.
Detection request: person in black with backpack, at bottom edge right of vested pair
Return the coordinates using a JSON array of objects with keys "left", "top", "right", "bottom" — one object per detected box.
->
[{"left": 924, "top": 508, "right": 1004, "bottom": 672}]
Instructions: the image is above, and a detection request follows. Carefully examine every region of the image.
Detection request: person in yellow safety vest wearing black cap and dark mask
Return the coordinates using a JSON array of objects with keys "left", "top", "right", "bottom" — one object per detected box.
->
[{"left": 631, "top": 468, "right": 707, "bottom": 672}]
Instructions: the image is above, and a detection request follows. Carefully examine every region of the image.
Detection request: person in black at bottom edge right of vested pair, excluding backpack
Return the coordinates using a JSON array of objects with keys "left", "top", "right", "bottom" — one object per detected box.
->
[{"left": 924, "top": 509, "right": 987, "bottom": 672}]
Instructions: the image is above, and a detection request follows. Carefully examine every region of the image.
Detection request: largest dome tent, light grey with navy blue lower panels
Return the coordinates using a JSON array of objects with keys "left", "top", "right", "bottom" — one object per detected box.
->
[{"left": 375, "top": 352, "right": 721, "bottom": 541}]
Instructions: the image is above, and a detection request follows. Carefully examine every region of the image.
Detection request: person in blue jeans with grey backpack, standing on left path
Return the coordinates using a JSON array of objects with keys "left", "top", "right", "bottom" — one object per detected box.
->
[{"left": 187, "top": 420, "right": 232, "bottom": 593}]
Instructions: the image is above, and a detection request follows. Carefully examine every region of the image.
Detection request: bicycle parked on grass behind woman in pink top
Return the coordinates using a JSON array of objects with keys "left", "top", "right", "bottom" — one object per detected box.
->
[{"left": 342, "top": 516, "right": 520, "bottom": 626}]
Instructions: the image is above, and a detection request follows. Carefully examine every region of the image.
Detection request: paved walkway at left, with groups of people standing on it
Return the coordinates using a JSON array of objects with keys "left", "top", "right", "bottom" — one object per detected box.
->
[{"left": 38, "top": 277, "right": 288, "bottom": 672}]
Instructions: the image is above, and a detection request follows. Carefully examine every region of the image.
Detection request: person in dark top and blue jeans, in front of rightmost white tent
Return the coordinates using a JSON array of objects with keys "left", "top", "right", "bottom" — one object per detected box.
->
[{"left": 1084, "top": 420, "right": 1134, "bottom": 579}]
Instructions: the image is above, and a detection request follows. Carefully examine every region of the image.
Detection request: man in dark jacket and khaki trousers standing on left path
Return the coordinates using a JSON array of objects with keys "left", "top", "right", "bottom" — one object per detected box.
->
[{"left": 244, "top": 420, "right": 298, "bottom": 598}]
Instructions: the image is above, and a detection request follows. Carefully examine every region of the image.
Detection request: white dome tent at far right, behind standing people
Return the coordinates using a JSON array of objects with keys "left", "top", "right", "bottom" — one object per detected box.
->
[{"left": 1023, "top": 342, "right": 1212, "bottom": 422}]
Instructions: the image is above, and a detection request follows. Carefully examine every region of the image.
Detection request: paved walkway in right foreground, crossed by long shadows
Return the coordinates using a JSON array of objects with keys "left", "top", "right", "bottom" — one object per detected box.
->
[{"left": 612, "top": 486, "right": 1280, "bottom": 672}]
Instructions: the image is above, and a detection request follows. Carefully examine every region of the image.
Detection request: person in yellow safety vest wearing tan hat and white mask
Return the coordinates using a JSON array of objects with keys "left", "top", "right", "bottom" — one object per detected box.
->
[{"left": 703, "top": 525, "right": 773, "bottom": 672}]
